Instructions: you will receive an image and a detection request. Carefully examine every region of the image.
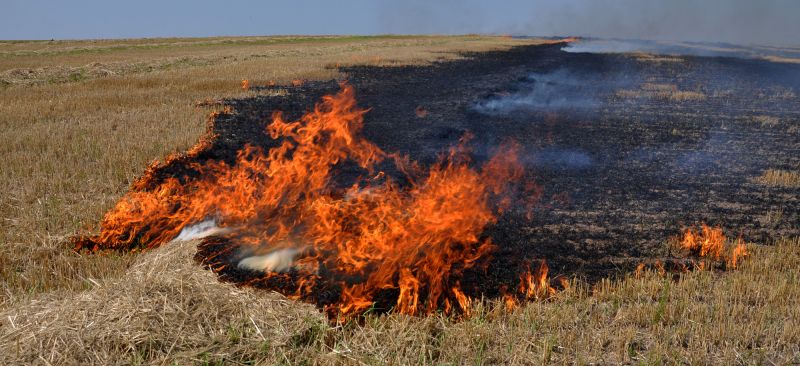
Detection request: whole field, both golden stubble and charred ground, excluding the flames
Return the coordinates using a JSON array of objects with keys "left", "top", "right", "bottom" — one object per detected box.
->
[{"left": 0, "top": 36, "right": 800, "bottom": 364}]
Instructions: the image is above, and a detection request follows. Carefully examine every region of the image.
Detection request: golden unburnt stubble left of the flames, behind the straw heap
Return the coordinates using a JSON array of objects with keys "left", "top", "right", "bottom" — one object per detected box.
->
[{"left": 0, "top": 36, "right": 531, "bottom": 305}]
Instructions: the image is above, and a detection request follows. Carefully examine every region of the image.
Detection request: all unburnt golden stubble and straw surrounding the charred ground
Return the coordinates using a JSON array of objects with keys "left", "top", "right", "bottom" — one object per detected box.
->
[{"left": 0, "top": 37, "right": 800, "bottom": 364}]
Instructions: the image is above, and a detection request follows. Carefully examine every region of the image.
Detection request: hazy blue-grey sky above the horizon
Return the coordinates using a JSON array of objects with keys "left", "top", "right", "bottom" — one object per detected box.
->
[{"left": 0, "top": 0, "right": 800, "bottom": 46}]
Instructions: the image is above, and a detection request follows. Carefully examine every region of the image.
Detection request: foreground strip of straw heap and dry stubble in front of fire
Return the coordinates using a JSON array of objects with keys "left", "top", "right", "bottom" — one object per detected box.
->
[{"left": 0, "top": 236, "right": 800, "bottom": 365}]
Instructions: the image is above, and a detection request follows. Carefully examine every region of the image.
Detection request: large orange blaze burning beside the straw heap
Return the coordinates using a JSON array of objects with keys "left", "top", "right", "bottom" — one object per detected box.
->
[{"left": 73, "top": 85, "right": 528, "bottom": 317}]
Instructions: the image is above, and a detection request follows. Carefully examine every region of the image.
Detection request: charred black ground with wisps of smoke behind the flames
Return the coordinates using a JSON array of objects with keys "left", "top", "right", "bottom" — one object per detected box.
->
[{"left": 181, "top": 41, "right": 800, "bottom": 308}]
